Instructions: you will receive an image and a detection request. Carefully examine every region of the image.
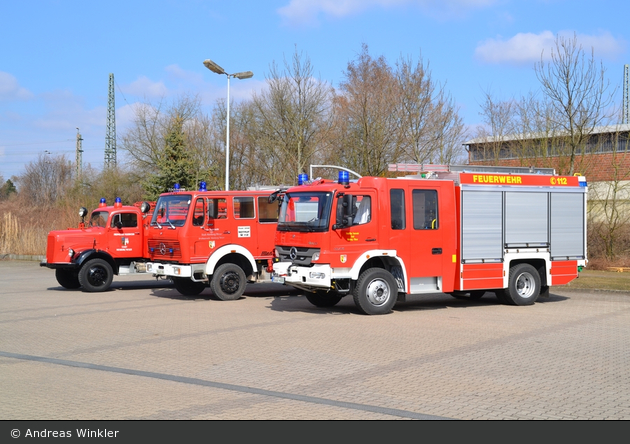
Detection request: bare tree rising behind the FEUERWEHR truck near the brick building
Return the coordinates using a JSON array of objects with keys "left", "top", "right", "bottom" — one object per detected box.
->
[{"left": 534, "top": 35, "right": 614, "bottom": 174}]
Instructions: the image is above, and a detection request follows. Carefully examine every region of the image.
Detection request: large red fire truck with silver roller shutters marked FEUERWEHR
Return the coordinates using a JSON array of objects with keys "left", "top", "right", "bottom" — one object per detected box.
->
[{"left": 272, "top": 165, "right": 587, "bottom": 314}]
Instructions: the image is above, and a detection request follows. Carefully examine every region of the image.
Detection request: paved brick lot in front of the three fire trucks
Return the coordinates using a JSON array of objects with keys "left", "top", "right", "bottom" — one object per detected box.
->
[{"left": 0, "top": 261, "right": 630, "bottom": 420}]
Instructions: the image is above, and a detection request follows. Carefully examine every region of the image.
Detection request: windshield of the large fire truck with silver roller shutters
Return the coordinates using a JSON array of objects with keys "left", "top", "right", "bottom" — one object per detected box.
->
[{"left": 278, "top": 191, "right": 333, "bottom": 231}]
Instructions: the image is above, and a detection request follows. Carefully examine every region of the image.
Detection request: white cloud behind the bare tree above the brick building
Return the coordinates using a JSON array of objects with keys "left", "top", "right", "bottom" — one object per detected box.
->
[{"left": 475, "top": 31, "right": 626, "bottom": 64}]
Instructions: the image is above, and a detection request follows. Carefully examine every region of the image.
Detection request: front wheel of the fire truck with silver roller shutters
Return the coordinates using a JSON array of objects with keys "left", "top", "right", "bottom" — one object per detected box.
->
[{"left": 352, "top": 268, "right": 398, "bottom": 315}]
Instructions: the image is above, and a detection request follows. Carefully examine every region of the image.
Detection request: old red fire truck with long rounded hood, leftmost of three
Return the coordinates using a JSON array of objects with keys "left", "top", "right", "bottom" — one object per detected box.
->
[{"left": 40, "top": 198, "right": 151, "bottom": 292}]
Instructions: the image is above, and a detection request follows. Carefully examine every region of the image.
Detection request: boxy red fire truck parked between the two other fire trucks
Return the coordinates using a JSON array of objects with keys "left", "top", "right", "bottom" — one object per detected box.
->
[{"left": 146, "top": 182, "right": 279, "bottom": 300}]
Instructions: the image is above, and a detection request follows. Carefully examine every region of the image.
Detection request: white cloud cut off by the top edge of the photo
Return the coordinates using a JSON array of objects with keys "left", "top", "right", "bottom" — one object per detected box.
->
[{"left": 277, "top": 0, "right": 497, "bottom": 26}]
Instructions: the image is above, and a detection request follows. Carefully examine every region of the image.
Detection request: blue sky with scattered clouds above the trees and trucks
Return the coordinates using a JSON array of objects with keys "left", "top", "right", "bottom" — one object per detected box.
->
[{"left": 0, "top": 0, "right": 630, "bottom": 180}]
